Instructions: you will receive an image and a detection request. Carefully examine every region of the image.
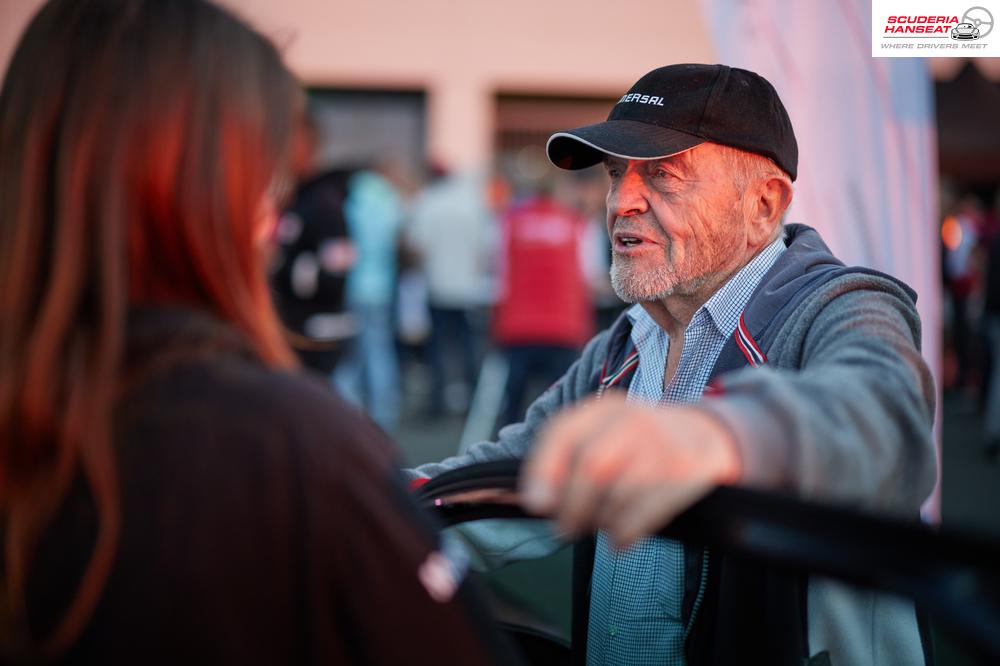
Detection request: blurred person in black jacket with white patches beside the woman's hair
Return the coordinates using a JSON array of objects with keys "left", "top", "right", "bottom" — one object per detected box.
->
[{"left": 271, "top": 113, "right": 357, "bottom": 376}]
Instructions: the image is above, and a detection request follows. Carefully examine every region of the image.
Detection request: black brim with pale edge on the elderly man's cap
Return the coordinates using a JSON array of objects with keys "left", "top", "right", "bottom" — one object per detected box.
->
[{"left": 545, "top": 120, "right": 705, "bottom": 171}]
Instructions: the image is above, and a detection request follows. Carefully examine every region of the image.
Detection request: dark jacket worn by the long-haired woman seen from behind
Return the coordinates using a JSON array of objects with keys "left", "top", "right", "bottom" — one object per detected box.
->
[{"left": 20, "top": 309, "right": 509, "bottom": 665}]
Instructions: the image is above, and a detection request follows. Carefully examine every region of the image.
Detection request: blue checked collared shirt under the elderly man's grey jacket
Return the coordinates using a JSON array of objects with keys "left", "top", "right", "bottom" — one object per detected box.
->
[{"left": 587, "top": 238, "right": 785, "bottom": 666}]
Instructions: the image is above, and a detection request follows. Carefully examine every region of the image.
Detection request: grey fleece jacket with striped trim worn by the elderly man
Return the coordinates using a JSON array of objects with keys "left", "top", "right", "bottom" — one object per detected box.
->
[{"left": 415, "top": 225, "right": 936, "bottom": 664}]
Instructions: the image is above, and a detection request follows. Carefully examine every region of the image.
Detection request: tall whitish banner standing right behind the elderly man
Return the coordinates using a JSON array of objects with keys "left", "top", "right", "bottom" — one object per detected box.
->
[{"left": 702, "top": 0, "right": 941, "bottom": 517}]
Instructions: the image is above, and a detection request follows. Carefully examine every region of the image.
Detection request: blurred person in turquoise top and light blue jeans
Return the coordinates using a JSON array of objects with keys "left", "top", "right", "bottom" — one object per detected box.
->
[{"left": 334, "top": 160, "right": 405, "bottom": 432}]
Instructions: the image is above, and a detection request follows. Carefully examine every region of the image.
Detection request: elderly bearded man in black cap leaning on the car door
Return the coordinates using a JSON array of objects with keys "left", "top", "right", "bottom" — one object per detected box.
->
[{"left": 410, "top": 65, "right": 935, "bottom": 664}]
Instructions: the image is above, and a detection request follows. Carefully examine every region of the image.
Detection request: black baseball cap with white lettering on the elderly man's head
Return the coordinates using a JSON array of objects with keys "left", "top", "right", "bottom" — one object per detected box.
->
[{"left": 545, "top": 64, "right": 799, "bottom": 180}]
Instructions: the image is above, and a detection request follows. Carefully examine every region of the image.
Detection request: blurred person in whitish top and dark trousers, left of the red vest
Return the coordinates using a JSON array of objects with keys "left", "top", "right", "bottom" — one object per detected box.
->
[{"left": 406, "top": 165, "right": 495, "bottom": 416}]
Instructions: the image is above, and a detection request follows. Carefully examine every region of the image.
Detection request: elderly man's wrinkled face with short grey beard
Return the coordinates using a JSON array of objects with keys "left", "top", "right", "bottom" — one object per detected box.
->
[{"left": 605, "top": 143, "right": 747, "bottom": 303}]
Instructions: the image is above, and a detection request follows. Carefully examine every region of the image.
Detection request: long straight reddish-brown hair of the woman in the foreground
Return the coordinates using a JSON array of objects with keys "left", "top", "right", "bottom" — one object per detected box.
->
[{"left": 0, "top": 0, "right": 297, "bottom": 657}]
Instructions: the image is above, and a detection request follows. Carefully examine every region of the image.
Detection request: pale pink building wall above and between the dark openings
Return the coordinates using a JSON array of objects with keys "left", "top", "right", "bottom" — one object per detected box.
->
[{"left": 0, "top": 0, "right": 713, "bottom": 167}]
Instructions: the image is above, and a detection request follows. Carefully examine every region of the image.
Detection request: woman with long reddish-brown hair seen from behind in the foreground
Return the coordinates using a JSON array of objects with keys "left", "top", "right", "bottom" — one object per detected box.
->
[{"left": 0, "top": 0, "right": 510, "bottom": 665}]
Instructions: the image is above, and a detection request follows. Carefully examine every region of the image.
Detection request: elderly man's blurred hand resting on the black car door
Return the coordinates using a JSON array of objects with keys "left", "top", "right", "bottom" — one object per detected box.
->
[{"left": 521, "top": 395, "right": 741, "bottom": 547}]
